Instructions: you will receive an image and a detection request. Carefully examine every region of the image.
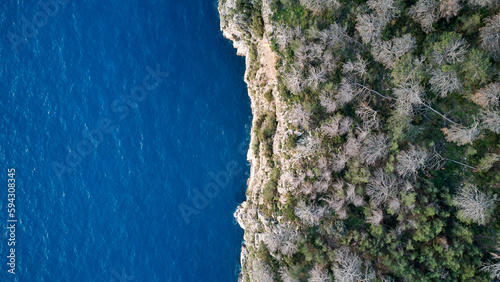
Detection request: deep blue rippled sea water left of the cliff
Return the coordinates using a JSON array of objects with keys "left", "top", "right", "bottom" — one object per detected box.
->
[{"left": 0, "top": 0, "right": 251, "bottom": 281}]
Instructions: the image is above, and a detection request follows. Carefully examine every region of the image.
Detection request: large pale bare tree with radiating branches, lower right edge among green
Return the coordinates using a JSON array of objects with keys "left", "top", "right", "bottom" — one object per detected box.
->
[{"left": 453, "top": 183, "right": 496, "bottom": 225}]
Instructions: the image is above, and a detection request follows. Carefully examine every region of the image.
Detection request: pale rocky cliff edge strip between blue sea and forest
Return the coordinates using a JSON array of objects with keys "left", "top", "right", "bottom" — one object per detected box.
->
[{"left": 218, "top": 0, "right": 285, "bottom": 281}]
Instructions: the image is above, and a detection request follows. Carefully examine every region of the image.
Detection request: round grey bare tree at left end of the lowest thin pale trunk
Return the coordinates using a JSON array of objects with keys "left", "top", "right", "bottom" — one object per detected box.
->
[{"left": 396, "top": 145, "right": 427, "bottom": 178}]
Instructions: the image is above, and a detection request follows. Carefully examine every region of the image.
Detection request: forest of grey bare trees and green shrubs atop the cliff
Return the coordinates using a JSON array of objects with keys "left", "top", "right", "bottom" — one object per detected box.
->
[{"left": 219, "top": 0, "right": 500, "bottom": 281}]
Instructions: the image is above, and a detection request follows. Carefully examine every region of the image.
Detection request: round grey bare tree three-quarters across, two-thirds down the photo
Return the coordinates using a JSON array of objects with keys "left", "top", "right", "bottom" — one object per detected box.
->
[{"left": 366, "top": 169, "right": 398, "bottom": 207}]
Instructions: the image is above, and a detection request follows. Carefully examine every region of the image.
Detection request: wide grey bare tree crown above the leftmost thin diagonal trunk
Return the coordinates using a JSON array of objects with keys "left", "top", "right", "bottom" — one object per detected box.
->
[{"left": 371, "top": 34, "right": 417, "bottom": 68}]
